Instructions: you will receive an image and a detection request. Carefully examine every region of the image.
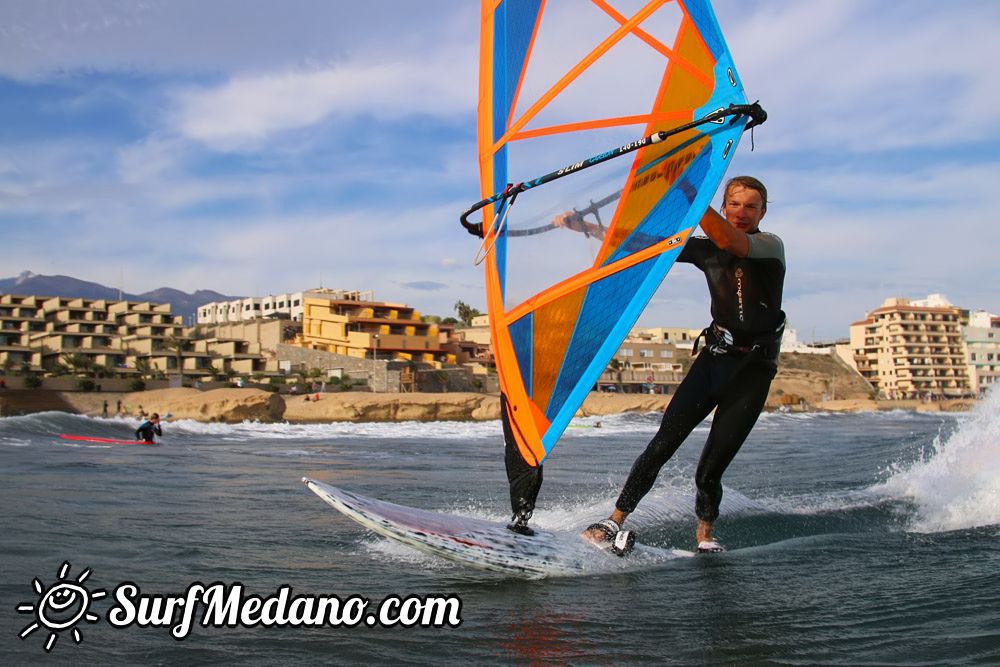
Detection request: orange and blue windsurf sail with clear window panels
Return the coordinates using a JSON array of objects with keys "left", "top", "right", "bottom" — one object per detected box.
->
[{"left": 462, "top": 0, "right": 766, "bottom": 514}]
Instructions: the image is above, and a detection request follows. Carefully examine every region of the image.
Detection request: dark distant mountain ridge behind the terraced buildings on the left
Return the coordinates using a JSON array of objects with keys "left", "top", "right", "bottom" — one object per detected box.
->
[{"left": 0, "top": 271, "right": 240, "bottom": 324}]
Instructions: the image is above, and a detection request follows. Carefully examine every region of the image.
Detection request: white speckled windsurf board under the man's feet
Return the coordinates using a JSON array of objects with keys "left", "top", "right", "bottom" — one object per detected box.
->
[{"left": 302, "top": 477, "right": 693, "bottom": 577}]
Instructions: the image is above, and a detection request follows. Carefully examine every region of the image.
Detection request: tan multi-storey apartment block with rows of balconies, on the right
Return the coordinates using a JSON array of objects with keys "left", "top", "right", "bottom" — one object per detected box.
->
[{"left": 850, "top": 294, "right": 973, "bottom": 399}]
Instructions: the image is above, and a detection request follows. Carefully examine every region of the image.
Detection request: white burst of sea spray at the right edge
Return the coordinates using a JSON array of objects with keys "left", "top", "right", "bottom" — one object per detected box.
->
[{"left": 873, "top": 389, "right": 1000, "bottom": 533}]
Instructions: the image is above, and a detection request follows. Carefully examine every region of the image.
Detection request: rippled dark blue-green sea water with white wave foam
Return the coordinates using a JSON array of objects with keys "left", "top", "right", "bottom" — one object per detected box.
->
[{"left": 0, "top": 394, "right": 1000, "bottom": 666}]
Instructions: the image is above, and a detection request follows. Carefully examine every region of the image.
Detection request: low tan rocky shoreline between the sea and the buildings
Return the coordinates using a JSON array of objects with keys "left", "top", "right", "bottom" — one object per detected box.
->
[{"left": 0, "top": 388, "right": 974, "bottom": 423}]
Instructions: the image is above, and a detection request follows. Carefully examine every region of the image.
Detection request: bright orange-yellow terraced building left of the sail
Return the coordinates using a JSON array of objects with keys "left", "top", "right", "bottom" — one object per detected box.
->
[{"left": 298, "top": 289, "right": 456, "bottom": 366}]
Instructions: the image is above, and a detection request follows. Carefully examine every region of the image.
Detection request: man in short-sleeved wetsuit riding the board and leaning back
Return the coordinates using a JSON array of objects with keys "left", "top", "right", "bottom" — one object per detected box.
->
[{"left": 583, "top": 176, "right": 785, "bottom": 552}]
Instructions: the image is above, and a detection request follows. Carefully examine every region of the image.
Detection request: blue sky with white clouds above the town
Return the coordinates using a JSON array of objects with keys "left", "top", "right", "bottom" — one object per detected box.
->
[{"left": 0, "top": 0, "right": 1000, "bottom": 342}]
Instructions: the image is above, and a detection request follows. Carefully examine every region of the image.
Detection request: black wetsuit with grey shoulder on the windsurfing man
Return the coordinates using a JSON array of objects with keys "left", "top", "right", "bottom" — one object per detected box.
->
[{"left": 615, "top": 231, "right": 785, "bottom": 522}]
